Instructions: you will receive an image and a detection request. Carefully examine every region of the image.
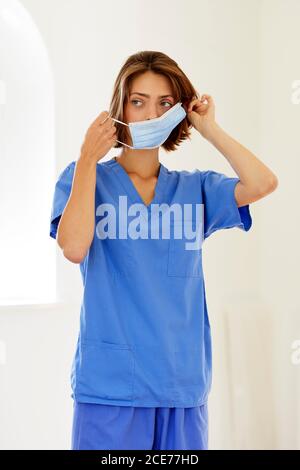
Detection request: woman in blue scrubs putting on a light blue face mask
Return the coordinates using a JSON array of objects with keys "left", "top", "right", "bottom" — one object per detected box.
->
[{"left": 50, "top": 51, "right": 277, "bottom": 449}]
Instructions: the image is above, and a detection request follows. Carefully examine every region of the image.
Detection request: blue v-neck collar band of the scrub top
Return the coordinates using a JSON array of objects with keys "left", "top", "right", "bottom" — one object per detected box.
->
[{"left": 106, "top": 157, "right": 168, "bottom": 215}]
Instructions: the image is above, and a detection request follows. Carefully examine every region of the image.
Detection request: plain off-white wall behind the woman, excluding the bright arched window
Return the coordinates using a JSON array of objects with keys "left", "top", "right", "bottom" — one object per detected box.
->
[{"left": 0, "top": 0, "right": 300, "bottom": 449}]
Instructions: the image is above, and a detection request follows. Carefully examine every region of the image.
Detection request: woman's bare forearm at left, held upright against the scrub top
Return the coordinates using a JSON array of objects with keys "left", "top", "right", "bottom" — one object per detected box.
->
[{"left": 57, "top": 156, "right": 97, "bottom": 263}]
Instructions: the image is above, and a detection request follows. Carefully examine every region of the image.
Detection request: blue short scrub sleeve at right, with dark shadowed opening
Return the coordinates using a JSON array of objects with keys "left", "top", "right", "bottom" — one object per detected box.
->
[{"left": 200, "top": 170, "right": 252, "bottom": 239}]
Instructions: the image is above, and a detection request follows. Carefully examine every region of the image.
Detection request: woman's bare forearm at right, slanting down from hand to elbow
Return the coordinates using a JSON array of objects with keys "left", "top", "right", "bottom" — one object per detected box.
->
[{"left": 207, "top": 124, "right": 277, "bottom": 194}]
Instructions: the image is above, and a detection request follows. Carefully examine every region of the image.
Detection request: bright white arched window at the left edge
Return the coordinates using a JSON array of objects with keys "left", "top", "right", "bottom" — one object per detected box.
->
[{"left": 0, "top": 0, "right": 56, "bottom": 305}]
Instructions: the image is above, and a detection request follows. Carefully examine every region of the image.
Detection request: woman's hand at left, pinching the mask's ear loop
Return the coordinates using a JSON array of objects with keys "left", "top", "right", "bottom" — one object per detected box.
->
[{"left": 81, "top": 111, "right": 117, "bottom": 163}]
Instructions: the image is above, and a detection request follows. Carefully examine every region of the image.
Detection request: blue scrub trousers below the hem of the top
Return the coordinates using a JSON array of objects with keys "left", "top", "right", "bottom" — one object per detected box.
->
[{"left": 72, "top": 400, "right": 208, "bottom": 450}]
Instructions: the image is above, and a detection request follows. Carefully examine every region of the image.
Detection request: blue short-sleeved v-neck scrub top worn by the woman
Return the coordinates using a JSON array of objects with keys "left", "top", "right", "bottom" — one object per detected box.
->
[{"left": 50, "top": 158, "right": 252, "bottom": 407}]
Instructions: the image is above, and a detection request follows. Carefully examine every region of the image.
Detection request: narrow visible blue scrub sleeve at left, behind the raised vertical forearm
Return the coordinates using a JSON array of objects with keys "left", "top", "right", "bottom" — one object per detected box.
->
[{"left": 50, "top": 161, "right": 76, "bottom": 238}]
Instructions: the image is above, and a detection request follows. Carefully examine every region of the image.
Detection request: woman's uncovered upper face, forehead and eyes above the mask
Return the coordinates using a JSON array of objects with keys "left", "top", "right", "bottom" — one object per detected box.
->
[{"left": 124, "top": 71, "right": 176, "bottom": 123}]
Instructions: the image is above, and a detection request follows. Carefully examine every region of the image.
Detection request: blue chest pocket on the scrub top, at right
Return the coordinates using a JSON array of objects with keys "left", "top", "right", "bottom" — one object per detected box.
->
[{"left": 167, "top": 220, "right": 202, "bottom": 277}]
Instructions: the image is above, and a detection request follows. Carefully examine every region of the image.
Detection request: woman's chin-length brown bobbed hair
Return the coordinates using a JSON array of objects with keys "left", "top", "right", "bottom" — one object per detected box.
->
[{"left": 109, "top": 51, "right": 199, "bottom": 152}]
